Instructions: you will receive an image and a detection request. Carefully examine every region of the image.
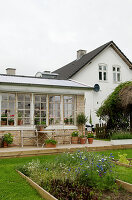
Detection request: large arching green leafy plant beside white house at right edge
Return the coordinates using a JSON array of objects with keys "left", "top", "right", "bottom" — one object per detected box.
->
[{"left": 96, "top": 81, "right": 132, "bottom": 129}]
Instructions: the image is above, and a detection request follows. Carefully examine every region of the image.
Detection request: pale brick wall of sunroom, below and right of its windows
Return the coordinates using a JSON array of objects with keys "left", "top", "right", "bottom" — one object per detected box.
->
[{"left": 0, "top": 95, "right": 85, "bottom": 146}]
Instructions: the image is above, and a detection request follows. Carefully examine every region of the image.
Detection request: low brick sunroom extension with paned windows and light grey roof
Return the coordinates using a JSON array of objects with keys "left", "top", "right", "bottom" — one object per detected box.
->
[{"left": 0, "top": 69, "right": 93, "bottom": 146}]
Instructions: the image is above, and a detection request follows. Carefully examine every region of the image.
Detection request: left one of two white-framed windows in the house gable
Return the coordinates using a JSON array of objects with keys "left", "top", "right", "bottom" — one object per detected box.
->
[{"left": 98, "top": 63, "right": 108, "bottom": 82}]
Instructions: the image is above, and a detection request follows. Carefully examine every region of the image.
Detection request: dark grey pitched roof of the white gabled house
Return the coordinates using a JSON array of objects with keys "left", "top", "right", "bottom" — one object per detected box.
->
[{"left": 54, "top": 41, "right": 132, "bottom": 80}]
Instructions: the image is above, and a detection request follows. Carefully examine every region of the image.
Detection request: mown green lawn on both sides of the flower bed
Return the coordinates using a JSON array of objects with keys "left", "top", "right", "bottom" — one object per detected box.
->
[{"left": 0, "top": 149, "right": 132, "bottom": 200}]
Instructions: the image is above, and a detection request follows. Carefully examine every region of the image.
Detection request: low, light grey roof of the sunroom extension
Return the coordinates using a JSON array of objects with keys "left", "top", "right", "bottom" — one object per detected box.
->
[{"left": 0, "top": 74, "right": 93, "bottom": 89}]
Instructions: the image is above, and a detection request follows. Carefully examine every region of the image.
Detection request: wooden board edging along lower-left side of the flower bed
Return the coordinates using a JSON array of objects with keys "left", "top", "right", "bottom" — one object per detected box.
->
[{"left": 16, "top": 170, "right": 58, "bottom": 200}]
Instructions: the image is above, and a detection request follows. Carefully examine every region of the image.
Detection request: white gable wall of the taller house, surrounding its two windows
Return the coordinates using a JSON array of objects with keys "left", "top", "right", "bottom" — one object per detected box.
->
[{"left": 71, "top": 47, "right": 132, "bottom": 124}]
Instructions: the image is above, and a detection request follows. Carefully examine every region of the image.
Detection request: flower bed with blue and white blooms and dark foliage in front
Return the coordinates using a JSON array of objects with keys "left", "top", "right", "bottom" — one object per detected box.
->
[{"left": 19, "top": 151, "right": 132, "bottom": 200}]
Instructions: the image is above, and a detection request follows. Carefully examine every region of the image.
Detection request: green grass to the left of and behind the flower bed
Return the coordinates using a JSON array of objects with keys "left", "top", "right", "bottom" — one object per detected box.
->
[{"left": 0, "top": 155, "right": 55, "bottom": 200}]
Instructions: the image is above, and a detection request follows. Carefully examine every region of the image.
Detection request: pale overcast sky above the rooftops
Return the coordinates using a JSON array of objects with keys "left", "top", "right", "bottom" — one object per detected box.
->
[{"left": 0, "top": 0, "right": 132, "bottom": 75}]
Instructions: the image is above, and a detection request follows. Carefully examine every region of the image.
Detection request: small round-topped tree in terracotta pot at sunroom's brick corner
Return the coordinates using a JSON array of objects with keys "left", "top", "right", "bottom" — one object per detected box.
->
[{"left": 77, "top": 113, "right": 88, "bottom": 144}]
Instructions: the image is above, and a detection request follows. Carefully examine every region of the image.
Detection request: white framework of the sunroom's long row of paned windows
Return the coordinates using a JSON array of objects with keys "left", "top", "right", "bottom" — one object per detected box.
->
[{"left": 0, "top": 92, "right": 77, "bottom": 130}]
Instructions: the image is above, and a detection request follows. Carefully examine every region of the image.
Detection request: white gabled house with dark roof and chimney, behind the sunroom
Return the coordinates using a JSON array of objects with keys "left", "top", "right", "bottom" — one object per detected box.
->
[{"left": 53, "top": 41, "right": 132, "bottom": 124}]
